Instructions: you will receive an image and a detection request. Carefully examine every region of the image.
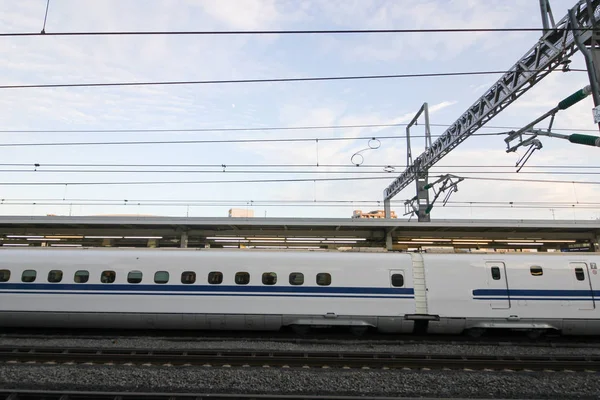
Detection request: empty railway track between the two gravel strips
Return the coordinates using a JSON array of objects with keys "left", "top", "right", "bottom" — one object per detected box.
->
[{"left": 0, "top": 346, "right": 600, "bottom": 371}]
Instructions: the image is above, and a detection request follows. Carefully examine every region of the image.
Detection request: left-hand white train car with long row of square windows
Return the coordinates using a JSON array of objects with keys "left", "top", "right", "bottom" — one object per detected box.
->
[{"left": 0, "top": 248, "right": 415, "bottom": 332}]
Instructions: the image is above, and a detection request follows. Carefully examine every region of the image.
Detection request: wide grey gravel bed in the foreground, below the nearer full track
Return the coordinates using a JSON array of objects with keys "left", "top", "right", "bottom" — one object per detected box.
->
[{"left": 0, "top": 364, "right": 600, "bottom": 400}]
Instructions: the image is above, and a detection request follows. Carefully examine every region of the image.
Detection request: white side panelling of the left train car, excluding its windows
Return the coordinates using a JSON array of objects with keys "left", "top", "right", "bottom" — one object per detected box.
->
[{"left": 0, "top": 249, "right": 414, "bottom": 329}]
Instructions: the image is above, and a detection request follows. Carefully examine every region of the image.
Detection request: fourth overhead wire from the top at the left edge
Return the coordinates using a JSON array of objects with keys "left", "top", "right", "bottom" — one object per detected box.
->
[{"left": 0, "top": 132, "right": 508, "bottom": 147}]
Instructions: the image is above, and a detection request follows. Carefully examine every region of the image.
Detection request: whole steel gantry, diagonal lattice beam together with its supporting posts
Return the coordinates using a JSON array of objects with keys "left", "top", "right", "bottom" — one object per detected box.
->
[{"left": 384, "top": 0, "right": 600, "bottom": 222}]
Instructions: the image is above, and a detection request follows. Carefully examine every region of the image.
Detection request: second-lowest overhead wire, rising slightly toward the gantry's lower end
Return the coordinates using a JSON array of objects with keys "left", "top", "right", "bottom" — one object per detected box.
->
[{"left": 0, "top": 176, "right": 600, "bottom": 186}]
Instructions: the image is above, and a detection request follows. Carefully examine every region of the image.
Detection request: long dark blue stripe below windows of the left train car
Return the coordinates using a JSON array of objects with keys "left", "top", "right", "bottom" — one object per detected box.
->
[{"left": 0, "top": 283, "right": 414, "bottom": 296}]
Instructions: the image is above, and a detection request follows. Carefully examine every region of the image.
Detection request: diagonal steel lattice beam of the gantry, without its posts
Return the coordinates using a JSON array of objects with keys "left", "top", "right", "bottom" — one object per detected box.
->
[{"left": 384, "top": 0, "right": 600, "bottom": 200}]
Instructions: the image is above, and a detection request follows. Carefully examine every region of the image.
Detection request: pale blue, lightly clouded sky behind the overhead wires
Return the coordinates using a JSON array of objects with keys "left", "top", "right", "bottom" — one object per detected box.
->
[{"left": 0, "top": 0, "right": 600, "bottom": 220}]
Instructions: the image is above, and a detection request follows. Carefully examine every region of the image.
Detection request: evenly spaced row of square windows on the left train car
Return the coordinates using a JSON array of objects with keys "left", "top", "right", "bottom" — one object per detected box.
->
[{"left": 0, "top": 269, "right": 331, "bottom": 286}]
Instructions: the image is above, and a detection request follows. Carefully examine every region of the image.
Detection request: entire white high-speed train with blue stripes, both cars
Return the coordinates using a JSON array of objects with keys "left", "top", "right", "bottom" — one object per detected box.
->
[{"left": 0, "top": 248, "right": 600, "bottom": 335}]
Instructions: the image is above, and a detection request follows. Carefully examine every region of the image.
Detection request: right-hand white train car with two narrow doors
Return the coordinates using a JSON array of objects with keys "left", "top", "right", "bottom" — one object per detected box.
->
[{"left": 415, "top": 253, "right": 600, "bottom": 336}]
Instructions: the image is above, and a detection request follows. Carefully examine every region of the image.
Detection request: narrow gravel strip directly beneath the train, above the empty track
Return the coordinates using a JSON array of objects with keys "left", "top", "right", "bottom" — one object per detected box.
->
[{"left": 0, "top": 337, "right": 600, "bottom": 356}]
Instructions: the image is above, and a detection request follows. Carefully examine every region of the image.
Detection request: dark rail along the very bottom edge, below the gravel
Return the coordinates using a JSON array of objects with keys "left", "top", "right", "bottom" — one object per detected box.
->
[{"left": 0, "top": 389, "right": 502, "bottom": 400}]
